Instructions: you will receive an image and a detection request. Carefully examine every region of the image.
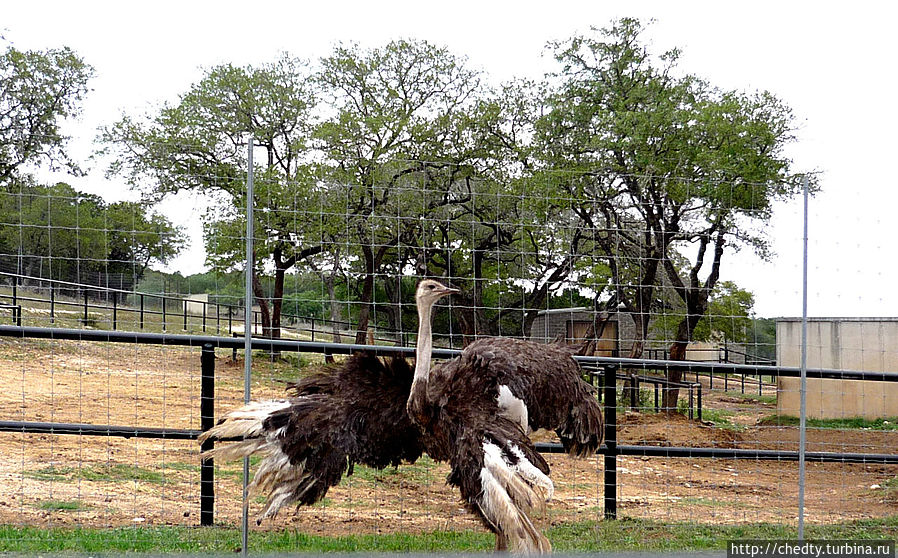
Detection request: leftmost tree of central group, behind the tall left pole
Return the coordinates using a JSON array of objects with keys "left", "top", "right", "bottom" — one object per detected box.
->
[{"left": 101, "top": 55, "right": 322, "bottom": 337}]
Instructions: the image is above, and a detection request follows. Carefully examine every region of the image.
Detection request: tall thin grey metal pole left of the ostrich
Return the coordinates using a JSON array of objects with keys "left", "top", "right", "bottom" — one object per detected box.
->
[{"left": 241, "top": 135, "right": 255, "bottom": 556}]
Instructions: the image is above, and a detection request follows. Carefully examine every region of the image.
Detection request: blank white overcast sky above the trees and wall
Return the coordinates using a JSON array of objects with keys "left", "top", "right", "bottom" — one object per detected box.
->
[{"left": 0, "top": 0, "right": 898, "bottom": 317}]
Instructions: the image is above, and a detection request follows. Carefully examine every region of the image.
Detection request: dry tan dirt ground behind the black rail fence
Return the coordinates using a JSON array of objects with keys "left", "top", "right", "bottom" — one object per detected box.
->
[{"left": 0, "top": 339, "right": 898, "bottom": 534}]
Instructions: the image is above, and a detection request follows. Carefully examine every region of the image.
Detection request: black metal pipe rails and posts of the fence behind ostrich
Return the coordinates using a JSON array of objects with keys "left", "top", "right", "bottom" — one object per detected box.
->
[{"left": 0, "top": 325, "right": 898, "bottom": 525}]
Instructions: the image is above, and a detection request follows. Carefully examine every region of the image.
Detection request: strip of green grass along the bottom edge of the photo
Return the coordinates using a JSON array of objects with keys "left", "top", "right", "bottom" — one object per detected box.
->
[{"left": 0, "top": 516, "right": 898, "bottom": 554}]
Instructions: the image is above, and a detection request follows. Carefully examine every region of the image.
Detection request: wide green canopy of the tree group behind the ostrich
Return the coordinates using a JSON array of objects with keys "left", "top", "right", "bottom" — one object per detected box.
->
[{"left": 94, "top": 19, "right": 797, "bottom": 343}]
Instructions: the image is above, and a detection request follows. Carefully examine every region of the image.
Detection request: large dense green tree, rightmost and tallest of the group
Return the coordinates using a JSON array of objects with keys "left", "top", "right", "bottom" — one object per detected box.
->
[{"left": 542, "top": 19, "right": 798, "bottom": 409}]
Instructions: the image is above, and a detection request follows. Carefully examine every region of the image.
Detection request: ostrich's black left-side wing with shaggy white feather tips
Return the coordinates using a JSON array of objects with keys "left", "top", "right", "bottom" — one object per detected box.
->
[{"left": 200, "top": 353, "right": 423, "bottom": 522}]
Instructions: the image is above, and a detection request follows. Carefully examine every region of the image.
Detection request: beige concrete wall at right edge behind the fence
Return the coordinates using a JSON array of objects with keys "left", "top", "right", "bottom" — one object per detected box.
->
[{"left": 776, "top": 318, "right": 898, "bottom": 419}]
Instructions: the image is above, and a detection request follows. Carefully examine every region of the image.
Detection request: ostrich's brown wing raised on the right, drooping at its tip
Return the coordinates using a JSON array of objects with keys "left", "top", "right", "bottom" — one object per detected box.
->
[{"left": 461, "top": 338, "right": 603, "bottom": 457}]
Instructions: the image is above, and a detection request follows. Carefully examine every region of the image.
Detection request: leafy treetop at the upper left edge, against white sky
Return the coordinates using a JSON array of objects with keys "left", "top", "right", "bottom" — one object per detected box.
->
[{"left": 0, "top": 47, "right": 94, "bottom": 187}]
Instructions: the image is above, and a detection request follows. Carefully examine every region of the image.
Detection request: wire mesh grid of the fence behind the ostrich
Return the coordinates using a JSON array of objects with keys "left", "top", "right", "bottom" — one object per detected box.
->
[{"left": 0, "top": 148, "right": 898, "bottom": 556}]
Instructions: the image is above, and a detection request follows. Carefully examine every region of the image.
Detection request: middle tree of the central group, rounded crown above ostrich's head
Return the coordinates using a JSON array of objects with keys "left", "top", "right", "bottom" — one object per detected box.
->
[{"left": 315, "top": 41, "right": 479, "bottom": 343}]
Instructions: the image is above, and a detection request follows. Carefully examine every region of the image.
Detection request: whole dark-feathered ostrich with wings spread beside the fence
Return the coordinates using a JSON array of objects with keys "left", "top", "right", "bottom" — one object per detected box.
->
[{"left": 200, "top": 280, "right": 602, "bottom": 553}]
